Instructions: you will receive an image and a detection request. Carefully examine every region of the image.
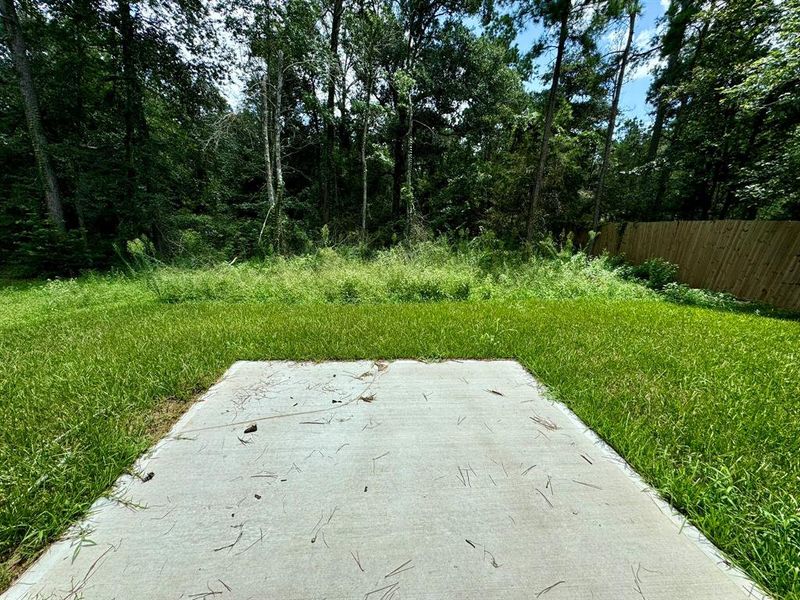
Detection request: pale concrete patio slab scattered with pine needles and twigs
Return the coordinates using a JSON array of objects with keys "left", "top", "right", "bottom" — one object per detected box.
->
[{"left": 2, "top": 361, "right": 761, "bottom": 600}]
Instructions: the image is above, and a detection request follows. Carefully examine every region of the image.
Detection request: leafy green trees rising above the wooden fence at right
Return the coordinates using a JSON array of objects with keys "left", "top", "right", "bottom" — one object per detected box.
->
[{"left": 608, "top": 0, "right": 800, "bottom": 220}]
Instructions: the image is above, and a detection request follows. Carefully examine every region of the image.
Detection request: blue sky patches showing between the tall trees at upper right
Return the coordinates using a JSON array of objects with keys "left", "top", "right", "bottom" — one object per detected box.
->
[{"left": 517, "top": 0, "right": 669, "bottom": 122}]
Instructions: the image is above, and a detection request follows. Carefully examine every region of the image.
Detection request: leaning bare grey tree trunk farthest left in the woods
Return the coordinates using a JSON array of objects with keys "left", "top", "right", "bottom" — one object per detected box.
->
[{"left": 0, "top": 0, "right": 66, "bottom": 233}]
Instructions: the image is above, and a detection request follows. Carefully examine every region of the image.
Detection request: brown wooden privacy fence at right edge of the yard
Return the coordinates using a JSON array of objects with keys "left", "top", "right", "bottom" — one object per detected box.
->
[{"left": 594, "top": 221, "right": 800, "bottom": 311}]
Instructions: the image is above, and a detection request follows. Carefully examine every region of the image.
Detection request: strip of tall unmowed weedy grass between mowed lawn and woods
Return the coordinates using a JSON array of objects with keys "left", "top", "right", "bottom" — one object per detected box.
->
[{"left": 147, "top": 243, "right": 652, "bottom": 304}]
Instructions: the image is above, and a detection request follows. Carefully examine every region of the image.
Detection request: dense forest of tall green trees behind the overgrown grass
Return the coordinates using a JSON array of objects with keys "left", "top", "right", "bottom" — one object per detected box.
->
[{"left": 0, "top": 0, "right": 800, "bottom": 276}]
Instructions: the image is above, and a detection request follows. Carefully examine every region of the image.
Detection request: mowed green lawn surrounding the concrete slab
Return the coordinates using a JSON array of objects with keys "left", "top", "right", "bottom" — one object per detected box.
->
[{"left": 0, "top": 256, "right": 800, "bottom": 600}]
